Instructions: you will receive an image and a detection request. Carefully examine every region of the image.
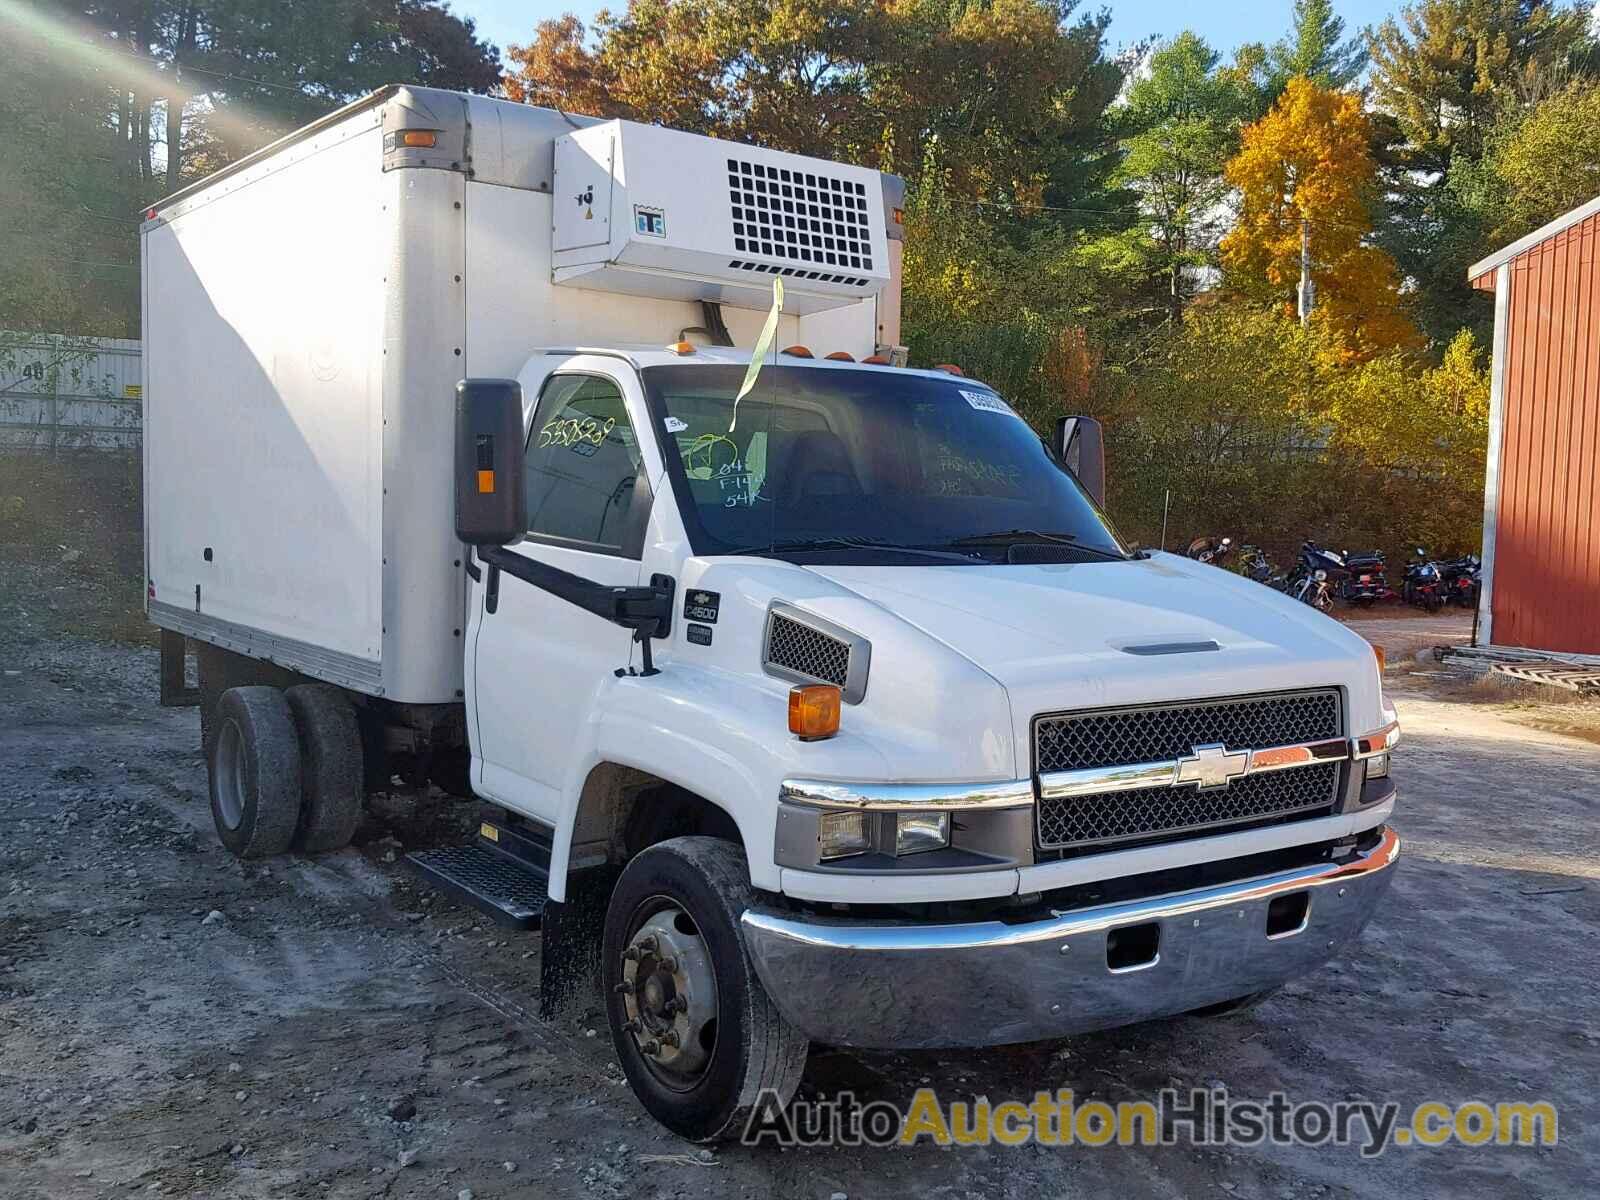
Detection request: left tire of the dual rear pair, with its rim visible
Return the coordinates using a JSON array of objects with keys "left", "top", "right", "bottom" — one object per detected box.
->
[{"left": 206, "top": 686, "right": 301, "bottom": 858}]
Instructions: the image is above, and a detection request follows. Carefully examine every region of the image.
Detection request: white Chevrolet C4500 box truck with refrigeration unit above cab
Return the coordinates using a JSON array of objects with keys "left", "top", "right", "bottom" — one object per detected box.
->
[{"left": 142, "top": 88, "right": 1398, "bottom": 1139}]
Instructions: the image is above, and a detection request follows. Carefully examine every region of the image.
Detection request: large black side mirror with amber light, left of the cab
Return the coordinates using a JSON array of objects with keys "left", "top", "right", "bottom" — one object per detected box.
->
[{"left": 456, "top": 379, "right": 528, "bottom": 546}]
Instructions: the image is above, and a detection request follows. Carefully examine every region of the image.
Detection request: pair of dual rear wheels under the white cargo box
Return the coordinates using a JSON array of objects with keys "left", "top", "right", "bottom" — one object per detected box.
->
[{"left": 206, "top": 683, "right": 363, "bottom": 858}]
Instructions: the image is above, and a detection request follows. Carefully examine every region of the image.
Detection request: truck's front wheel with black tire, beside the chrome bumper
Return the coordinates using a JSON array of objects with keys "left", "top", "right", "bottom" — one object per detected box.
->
[{"left": 600, "top": 837, "right": 806, "bottom": 1142}]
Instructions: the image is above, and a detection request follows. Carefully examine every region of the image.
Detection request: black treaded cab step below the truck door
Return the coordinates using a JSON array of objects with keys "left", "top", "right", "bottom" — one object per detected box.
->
[{"left": 406, "top": 821, "right": 550, "bottom": 930}]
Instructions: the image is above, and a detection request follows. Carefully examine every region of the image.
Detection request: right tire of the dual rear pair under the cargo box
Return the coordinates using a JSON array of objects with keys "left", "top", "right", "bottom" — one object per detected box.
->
[{"left": 283, "top": 683, "right": 365, "bottom": 854}]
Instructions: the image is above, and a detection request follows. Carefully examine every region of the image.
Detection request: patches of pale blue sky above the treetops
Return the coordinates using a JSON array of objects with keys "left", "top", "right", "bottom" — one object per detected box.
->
[{"left": 450, "top": 0, "right": 1402, "bottom": 56}]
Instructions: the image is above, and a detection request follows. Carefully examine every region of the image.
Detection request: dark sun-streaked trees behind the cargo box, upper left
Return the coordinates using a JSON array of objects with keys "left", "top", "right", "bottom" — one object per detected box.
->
[{"left": 0, "top": 0, "right": 499, "bottom": 334}]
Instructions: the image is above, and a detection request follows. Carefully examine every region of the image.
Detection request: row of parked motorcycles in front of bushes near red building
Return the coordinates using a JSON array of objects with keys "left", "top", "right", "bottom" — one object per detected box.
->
[{"left": 1184, "top": 536, "right": 1482, "bottom": 613}]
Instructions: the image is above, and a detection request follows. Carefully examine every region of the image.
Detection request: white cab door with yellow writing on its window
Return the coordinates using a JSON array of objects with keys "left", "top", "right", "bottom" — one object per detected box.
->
[{"left": 467, "top": 360, "right": 659, "bottom": 824}]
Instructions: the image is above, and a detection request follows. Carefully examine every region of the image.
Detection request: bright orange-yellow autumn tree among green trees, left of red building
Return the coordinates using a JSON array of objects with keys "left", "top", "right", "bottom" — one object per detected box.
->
[{"left": 1222, "top": 78, "right": 1421, "bottom": 357}]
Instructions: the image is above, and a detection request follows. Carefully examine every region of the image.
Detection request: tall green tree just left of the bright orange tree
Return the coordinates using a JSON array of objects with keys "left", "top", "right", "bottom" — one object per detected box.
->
[{"left": 1114, "top": 32, "right": 1253, "bottom": 320}]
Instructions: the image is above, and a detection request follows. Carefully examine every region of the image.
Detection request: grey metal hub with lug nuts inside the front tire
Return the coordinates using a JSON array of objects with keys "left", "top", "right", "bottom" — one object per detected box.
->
[{"left": 616, "top": 907, "right": 717, "bottom": 1077}]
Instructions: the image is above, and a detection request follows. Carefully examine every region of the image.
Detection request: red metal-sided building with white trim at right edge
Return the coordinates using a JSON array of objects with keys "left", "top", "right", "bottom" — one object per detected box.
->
[{"left": 1467, "top": 197, "right": 1600, "bottom": 654}]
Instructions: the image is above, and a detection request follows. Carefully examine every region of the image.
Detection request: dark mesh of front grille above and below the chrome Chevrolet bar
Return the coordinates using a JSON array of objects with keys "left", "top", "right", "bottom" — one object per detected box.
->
[{"left": 1034, "top": 690, "right": 1342, "bottom": 850}]
